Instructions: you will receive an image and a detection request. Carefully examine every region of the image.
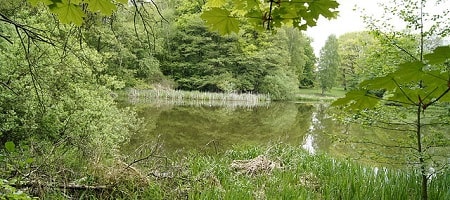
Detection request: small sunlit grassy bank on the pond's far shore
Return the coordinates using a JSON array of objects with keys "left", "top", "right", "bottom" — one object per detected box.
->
[{"left": 295, "top": 88, "right": 346, "bottom": 101}]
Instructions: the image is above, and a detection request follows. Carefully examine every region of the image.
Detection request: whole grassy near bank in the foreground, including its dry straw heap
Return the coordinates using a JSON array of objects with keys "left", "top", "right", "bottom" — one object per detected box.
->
[{"left": 37, "top": 145, "right": 450, "bottom": 199}]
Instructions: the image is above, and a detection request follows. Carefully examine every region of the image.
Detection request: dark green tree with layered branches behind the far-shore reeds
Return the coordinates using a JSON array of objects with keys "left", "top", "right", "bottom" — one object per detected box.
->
[{"left": 158, "top": 5, "right": 243, "bottom": 92}]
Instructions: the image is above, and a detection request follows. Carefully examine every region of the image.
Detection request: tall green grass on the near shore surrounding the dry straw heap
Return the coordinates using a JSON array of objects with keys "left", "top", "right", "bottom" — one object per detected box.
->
[{"left": 118, "top": 145, "right": 450, "bottom": 199}]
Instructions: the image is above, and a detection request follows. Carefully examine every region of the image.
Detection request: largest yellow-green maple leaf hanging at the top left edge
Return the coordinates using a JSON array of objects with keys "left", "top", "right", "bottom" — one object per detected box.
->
[{"left": 50, "top": 0, "right": 84, "bottom": 26}]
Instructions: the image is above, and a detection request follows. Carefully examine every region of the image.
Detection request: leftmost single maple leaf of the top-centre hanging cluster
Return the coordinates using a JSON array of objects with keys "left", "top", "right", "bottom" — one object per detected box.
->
[{"left": 201, "top": 8, "right": 239, "bottom": 34}]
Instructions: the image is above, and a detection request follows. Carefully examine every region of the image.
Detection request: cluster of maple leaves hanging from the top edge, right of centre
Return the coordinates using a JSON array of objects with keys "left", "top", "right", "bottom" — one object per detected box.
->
[{"left": 202, "top": 0, "right": 339, "bottom": 34}]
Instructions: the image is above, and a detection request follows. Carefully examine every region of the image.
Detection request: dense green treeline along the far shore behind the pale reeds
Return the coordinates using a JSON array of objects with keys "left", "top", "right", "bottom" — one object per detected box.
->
[{"left": 82, "top": 0, "right": 316, "bottom": 99}]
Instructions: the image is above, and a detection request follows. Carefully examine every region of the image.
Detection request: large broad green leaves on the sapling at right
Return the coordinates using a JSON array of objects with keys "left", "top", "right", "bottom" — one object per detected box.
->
[{"left": 333, "top": 46, "right": 450, "bottom": 110}]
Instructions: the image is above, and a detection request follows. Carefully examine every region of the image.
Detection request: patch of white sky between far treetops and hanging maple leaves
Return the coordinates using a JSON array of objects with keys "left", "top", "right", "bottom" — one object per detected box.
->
[{"left": 306, "top": 0, "right": 386, "bottom": 56}]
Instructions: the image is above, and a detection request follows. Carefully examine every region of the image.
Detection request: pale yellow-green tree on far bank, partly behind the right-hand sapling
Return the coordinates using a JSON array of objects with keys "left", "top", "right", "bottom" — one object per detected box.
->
[{"left": 338, "top": 31, "right": 418, "bottom": 90}]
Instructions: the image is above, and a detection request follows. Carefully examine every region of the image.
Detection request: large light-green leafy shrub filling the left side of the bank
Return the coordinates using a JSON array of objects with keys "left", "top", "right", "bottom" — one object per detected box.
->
[{"left": 0, "top": 1, "right": 140, "bottom": 198}]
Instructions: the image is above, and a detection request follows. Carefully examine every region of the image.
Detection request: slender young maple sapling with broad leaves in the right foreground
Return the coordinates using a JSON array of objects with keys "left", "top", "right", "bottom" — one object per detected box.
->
[{"left": 333, "top": 0, "right": 450, "bottom": 200}]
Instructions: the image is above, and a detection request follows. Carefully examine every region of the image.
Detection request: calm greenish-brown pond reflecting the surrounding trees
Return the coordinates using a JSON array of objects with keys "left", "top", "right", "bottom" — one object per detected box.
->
[{"left": 124, "top": 99, "right": 416, "bottom": 164}]
